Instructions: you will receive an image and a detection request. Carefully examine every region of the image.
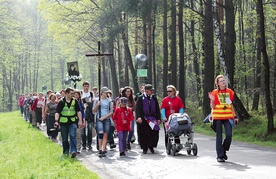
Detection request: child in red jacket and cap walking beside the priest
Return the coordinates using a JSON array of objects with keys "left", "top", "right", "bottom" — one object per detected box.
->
[{"left": 113, "top": 97, "right": 134, "bottom": 156}]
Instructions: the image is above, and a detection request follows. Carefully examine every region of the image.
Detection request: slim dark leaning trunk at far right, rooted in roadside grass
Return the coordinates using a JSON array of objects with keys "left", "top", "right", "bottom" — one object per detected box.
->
[{"left": 256, "top": 0, "right": 274, "bottom": 134}]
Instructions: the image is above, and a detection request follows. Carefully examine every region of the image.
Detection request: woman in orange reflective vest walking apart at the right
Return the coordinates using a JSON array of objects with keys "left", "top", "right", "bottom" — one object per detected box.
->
[{"left": 209, "top": 75, "right": 238, "bottom": 162}]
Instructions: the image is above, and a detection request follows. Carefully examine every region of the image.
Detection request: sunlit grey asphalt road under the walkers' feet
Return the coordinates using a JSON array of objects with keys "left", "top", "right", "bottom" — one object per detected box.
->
[{"left": 71, "top": 126, "right": 276, "bottom": 179}]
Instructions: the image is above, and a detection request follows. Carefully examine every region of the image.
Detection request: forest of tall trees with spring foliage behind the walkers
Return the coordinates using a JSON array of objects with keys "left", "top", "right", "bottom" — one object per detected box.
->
[{"left": 0, "top": 0, "right": 276, "bottom": 134}]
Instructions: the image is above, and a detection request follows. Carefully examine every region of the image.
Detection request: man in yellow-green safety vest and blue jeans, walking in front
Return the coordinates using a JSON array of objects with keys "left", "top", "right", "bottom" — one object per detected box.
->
[{"left": 55, "top": 88, "right": 82, "bottom": 158}]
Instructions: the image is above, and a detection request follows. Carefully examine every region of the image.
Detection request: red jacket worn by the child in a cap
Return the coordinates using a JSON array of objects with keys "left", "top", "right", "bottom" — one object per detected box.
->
[{"left": 113, "top": 107, "right": 134, "bottom": 132}]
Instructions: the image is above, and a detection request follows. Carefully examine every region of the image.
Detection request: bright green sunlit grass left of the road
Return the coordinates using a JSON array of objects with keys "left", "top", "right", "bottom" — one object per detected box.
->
[{"left": 0, "top": 111, "right": 98, "bottom": 179}]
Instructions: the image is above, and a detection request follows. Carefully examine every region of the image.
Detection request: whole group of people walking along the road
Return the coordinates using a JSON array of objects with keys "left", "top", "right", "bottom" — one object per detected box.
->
[{"left": 18, "top": 76, "right": 237, "bottom": 162}]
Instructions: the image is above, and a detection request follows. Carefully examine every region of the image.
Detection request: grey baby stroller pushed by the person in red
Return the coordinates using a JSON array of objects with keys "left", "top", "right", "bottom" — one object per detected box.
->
[{"left": 165, "top": 113, "right": 197, "bottom": 156}]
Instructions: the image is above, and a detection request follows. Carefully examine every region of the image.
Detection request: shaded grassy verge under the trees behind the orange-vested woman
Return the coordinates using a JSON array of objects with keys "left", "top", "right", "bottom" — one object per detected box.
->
[{"left": 187, "top": 108, "right": 276, "bottom": 148}]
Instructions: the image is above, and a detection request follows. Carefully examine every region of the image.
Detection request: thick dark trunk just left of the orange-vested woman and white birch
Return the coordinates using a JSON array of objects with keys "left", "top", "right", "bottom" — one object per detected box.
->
[{"left": 203, "top": 0, "right": 214, "bottom": 116}]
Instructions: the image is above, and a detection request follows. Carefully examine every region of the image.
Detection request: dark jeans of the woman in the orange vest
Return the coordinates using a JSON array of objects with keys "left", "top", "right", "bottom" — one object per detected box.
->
[{"left": 214, "top": 120, "right": 232, "bottom": 158}]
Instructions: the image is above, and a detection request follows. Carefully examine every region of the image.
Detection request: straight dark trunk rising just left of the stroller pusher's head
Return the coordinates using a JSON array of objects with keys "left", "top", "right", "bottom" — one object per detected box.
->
[{"left": 163, "top": 0, "right": 169, "bottom": 97}]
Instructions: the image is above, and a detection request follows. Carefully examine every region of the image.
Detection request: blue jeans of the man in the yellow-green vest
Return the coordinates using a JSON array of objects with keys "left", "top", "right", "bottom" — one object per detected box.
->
[{"left": 60, "top": 123, "right": 77, "bottom": 154}]
